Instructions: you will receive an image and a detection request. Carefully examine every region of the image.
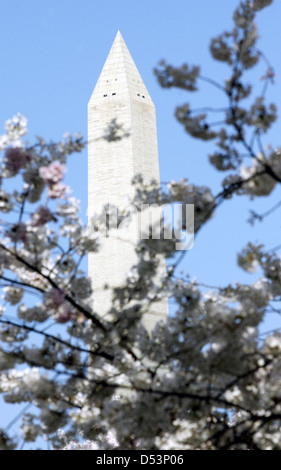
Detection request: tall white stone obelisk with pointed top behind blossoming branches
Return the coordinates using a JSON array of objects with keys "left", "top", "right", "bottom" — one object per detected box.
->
[{"left": 88, "top": 31, "right": 168, "bottom": 330}]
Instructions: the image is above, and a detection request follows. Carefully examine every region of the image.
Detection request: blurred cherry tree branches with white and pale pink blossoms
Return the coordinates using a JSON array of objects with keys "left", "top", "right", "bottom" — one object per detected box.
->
[{"left": 0, "top": 0, "right": 281, "bottom": 450}]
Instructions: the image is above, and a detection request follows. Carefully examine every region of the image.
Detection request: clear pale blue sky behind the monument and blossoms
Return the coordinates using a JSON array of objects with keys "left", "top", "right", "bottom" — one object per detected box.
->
[{"left": 0, "top": 0, "right": 281, "bottom": 444}]
